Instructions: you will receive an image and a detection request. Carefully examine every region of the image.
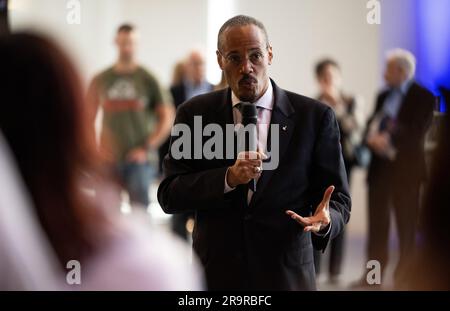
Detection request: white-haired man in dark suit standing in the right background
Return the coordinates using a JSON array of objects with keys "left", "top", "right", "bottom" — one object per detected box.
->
[{"left": 362, "top": 49, "right": 435, "bottom": 285}]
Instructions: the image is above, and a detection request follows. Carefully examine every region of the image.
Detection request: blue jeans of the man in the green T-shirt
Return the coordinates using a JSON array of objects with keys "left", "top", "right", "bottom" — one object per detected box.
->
[{"left": 118, "top": 163, "right": 155, "bottom": 207}]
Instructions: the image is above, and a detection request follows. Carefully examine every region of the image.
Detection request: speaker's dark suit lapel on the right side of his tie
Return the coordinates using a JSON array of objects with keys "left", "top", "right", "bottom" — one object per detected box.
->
[{"left": 250, "top": 80, "right": 295, "bottom": 207}]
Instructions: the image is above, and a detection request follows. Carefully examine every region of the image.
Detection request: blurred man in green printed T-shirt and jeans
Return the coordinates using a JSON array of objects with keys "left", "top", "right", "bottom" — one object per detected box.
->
[{"left": 88, "top": 24, "right": 174, "bottom": 208}]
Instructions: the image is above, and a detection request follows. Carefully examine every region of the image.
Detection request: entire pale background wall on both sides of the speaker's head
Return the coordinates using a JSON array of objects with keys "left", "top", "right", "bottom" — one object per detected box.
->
[{"left": 10, "top": 0, "right": 384, "bottom": 233}]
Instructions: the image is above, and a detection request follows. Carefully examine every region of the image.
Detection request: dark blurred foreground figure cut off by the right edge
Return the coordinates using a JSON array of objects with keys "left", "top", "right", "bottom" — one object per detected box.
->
[{"left": 404, "top": 91, "right": 450, "bottom": 291}]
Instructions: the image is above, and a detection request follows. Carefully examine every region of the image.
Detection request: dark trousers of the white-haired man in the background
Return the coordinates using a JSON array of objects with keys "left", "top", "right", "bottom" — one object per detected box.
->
[{"left": 367, "top": 174, "right": 420, "bottom": 283}]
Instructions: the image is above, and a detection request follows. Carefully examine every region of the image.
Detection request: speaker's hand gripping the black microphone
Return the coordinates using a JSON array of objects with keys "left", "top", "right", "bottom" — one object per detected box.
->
[{"left": 227, "top": 151, "right": 266, "bottom": 188}]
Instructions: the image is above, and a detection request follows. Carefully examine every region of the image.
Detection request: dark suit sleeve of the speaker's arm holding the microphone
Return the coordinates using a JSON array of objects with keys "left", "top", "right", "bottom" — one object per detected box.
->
[{"left": 158, "top": 105, "right": 228, "bottom": 214}]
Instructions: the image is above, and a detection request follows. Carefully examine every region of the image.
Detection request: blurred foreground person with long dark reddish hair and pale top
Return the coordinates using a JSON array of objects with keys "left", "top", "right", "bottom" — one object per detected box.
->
[{"left": 0, "top": 34, "right": 201, "bottom": 290}]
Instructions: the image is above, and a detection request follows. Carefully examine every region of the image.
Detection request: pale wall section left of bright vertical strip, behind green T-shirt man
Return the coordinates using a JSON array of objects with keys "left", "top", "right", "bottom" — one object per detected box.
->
[{"left": 10, "top": 0, "right": 207, "bottom": 84}]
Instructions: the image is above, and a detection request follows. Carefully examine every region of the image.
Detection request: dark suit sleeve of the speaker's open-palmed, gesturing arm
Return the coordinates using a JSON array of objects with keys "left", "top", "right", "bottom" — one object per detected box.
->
[{"left": 310, "top": 108, "right": 351, "bottom": 250}]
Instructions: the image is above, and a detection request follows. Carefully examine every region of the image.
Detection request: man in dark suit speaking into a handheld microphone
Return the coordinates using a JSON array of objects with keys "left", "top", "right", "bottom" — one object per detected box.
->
[{"left": 158, "top": 15, "right": 351, "bottom": 290}]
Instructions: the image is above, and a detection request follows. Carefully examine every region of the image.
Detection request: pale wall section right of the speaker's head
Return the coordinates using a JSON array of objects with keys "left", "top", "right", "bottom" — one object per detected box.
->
[{"left": 236, "top": 0, "right": 379, "bottom": 109}]
